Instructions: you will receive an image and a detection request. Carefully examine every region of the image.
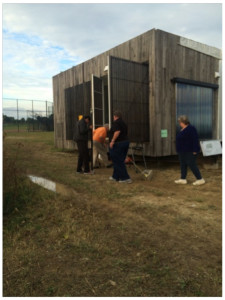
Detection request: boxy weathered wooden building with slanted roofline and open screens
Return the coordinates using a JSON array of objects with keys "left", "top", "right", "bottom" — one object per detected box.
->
[{"left": 53, "top": 29, "right": 222, "bottom": 156}]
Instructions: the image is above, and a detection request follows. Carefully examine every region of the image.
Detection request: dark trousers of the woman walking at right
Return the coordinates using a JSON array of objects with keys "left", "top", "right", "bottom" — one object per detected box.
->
[{"left": 179, "top": 152, "right": 202, "bottom": 179}]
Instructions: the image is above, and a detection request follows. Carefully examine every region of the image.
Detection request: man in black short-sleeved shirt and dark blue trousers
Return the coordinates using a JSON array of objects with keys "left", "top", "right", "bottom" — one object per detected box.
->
[{"left": 109, "top": 111, "right": 132, "bottom": 183}]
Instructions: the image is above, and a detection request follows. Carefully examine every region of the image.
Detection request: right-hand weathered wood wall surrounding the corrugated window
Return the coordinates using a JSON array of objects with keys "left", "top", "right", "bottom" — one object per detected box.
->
[{"left": 153, "top": 30, "right": 219, "bottom": 156}]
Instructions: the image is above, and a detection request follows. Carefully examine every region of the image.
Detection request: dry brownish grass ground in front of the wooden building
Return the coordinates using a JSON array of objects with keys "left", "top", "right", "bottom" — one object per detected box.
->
[{"left": 3, "top": 132, "right": 222, "bottom": 297}]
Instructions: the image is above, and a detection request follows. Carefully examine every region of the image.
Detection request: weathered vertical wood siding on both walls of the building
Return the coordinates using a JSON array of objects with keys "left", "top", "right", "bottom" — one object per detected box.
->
[{"left": 53, "top": 29, "right": 219, "bottom": 156}]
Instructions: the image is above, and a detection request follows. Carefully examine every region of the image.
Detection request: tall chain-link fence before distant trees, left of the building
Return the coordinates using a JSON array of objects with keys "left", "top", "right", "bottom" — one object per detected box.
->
[{"left": 2, "top": 98, "right": 54, "bottom": 131}]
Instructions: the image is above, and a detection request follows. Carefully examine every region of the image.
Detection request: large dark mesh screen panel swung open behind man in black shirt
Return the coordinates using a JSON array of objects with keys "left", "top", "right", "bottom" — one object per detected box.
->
[{"left": 108, "top": 56, "right": 149, "bottom": 143}]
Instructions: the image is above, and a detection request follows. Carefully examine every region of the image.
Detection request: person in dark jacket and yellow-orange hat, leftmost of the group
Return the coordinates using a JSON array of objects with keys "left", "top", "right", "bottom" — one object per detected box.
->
[{"left": 73, "top": 116, "right": 92, "bottom": 174}]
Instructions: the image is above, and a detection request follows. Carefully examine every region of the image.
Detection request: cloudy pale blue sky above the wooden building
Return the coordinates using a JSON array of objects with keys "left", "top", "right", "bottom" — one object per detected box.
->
[{"left": 3, "top": 3, "right": 222, "bottom": 100}]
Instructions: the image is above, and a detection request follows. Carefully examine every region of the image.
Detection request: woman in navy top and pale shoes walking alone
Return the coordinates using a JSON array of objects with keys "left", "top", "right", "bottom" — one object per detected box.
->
[{"left": 175, "top": 115, "right": 205, "bottom": 185}]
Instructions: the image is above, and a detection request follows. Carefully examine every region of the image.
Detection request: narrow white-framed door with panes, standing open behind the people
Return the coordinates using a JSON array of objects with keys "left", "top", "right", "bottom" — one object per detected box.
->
[{"left": 91, "top": 75, "right": 105, "bottom": 129}]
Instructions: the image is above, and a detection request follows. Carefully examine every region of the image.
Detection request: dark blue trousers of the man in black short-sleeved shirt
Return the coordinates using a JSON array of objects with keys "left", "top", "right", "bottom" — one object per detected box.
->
[{"left": 109, "top": 141, "right": 130, "bottom": 180}]
